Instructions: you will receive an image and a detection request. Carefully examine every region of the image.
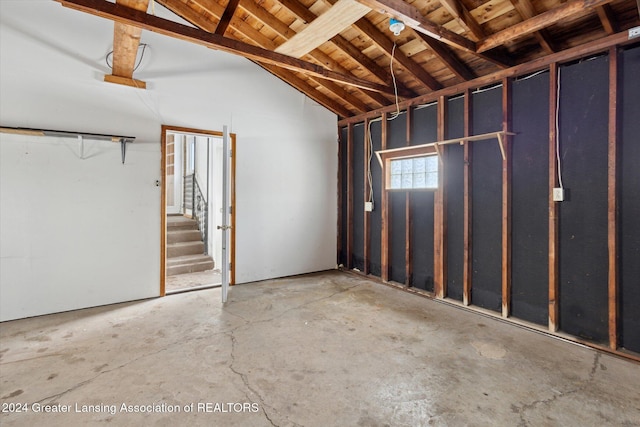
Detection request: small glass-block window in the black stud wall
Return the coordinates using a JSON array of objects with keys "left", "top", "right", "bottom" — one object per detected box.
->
[{"left": 387, "top": 155, "right": 438, "bottom": 190}]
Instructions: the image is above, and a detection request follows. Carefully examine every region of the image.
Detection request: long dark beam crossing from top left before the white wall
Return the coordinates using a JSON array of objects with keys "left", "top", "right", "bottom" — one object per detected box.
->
[{"left": 56, "top": 0, "right": 400, "bottom": 93}]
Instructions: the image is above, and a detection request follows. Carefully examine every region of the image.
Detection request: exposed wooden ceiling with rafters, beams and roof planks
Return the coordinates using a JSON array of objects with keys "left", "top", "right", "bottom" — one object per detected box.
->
[{"left": 56, "top": 0, "right": 640, "bottom": 118}]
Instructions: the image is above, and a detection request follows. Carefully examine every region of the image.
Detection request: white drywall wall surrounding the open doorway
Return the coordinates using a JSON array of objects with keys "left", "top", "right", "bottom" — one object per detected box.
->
[{"left": 0, "top": 0, "right": 337, "bottom": 320}]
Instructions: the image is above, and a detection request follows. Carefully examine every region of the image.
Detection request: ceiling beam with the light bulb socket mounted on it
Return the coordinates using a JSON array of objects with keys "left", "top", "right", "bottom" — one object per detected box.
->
[{"left": 358, "top": 0, "right": 476, "bottom": 53}]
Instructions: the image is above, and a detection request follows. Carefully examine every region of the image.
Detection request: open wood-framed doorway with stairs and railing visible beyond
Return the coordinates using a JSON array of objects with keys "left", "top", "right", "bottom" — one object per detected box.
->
[{"left": 160, "top": 126, "right": 235, "bottom": 295}]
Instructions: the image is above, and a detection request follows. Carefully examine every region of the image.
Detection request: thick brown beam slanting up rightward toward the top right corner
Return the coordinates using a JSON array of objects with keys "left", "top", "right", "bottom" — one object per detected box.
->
[{"left": 477, "top": 0, "right": 613, "bottom": 52}]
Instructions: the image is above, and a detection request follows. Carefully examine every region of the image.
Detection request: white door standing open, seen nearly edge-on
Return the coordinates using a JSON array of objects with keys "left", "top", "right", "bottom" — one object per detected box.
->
[{"left": 218, "top": 126, "right": 231, "bottom": 303}]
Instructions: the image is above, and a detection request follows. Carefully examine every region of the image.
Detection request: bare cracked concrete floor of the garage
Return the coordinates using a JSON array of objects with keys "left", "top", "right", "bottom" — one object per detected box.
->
[{"left": 0, "top": 272, "right": 640, "bottom": 426}]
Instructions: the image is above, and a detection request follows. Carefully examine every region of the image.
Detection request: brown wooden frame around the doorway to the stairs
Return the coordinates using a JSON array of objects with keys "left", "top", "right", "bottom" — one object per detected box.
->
[{"left": 160, "top": 125, "right": 236, "bottom": 296}]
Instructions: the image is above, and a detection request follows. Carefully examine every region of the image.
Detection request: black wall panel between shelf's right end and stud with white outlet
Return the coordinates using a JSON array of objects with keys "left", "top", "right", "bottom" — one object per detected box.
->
[{"left": 511, "top": 72, "right": 550, "bottom": 325}]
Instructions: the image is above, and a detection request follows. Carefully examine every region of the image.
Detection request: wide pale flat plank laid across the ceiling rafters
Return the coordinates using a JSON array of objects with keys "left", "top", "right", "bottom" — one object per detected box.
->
[{"left": 276, "top": 0, "right": 371, "bottom": 58}]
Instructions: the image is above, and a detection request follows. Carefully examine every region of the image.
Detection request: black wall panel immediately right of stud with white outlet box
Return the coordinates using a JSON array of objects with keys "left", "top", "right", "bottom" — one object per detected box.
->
[{"left": 559, "top": 56, "right": 609, "bottom": 342}]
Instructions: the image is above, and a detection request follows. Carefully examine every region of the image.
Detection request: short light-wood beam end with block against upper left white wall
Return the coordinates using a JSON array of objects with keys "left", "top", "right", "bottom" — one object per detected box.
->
[{"left": 105, "top": 0, "right": 149, "bottom": 88}]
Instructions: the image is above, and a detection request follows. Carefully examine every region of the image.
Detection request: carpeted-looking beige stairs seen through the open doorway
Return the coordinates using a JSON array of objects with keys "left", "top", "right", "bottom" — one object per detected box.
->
[{"left": 167, "top": 214, "right": 215, "bottom": 276}]
